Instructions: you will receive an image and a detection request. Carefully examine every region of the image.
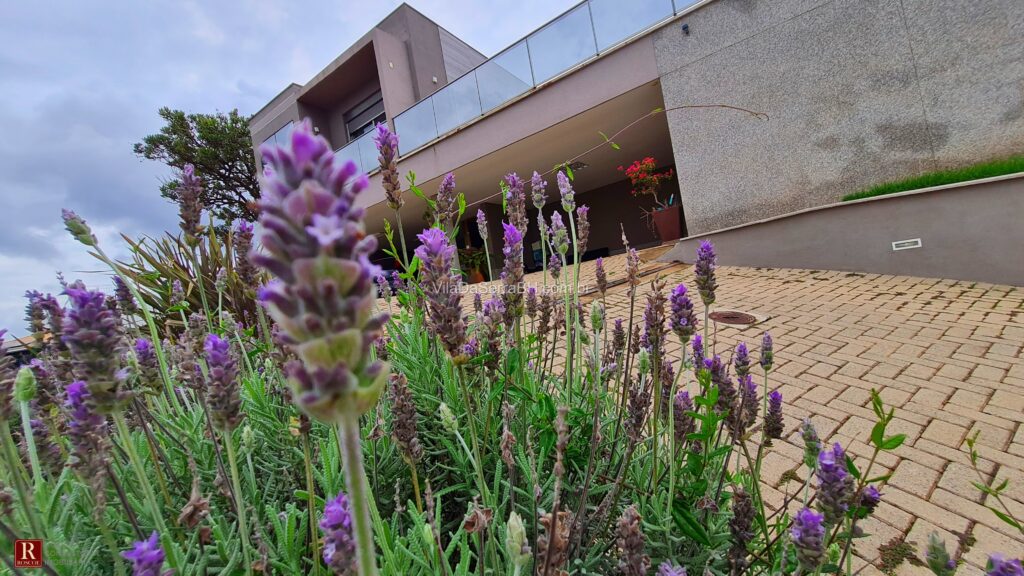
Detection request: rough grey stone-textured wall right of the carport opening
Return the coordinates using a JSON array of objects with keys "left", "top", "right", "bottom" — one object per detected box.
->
[{"left": 654, "top": 0, "right": 1024, "bottom": 235}]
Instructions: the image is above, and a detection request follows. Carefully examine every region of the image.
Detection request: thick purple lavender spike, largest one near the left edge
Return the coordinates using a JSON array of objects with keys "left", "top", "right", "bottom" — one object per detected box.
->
[{"left": 63, "top": 284, "right": 126, "bottom": 412}]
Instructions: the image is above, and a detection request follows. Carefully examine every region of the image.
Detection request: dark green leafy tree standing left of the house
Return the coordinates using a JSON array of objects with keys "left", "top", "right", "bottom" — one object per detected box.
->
[{"left": 133, "top": 108, "right": 259, "bottom": 222}]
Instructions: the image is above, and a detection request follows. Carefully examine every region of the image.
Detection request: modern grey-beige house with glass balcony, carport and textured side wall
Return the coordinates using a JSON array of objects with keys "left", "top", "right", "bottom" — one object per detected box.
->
[{"left": 251, "top": 0, "right": 1024, "bottom": 276}]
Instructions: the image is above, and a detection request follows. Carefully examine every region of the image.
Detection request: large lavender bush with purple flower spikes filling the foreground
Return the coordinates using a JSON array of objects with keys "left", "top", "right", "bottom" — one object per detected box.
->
[{"left": 0, "top": 117, "right": 1021, "bottom": 576}]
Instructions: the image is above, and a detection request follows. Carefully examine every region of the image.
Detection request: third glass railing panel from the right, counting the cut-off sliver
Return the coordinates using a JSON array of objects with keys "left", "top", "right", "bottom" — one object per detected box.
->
[{"left": 526, "top": 4, "right": 597, "bottom": 84}]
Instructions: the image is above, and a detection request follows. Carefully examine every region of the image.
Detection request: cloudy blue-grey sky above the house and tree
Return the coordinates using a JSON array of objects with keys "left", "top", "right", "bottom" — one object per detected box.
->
[{"left": 0, "top": 0, "right": 574, "bottom": 335}]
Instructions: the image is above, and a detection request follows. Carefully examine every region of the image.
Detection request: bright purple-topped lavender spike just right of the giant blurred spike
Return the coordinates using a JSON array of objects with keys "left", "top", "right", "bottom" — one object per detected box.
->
[{"left": 416, "top": 228, "right": 466, "bottom": 358}]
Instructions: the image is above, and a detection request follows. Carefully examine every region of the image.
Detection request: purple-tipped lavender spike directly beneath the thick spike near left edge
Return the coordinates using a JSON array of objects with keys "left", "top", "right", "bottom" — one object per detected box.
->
[{"left": 65, "top": 380, "right": 110, "bottom": 508}]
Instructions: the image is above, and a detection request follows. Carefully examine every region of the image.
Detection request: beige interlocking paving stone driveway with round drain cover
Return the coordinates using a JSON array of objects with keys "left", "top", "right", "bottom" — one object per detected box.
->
[{"left": 450, "top": 245, "right": 1024, "bottom": 574}]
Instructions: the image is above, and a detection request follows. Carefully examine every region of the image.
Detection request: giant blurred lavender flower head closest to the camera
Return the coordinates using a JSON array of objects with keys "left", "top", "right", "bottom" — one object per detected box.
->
[{"left": 250, "top": 120, "right": 388, "bottom": 422}]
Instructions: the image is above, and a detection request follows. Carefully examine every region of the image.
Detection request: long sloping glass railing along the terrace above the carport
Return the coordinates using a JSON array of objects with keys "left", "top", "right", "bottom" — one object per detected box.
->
[{"left": 391, "top": 0, "right": 700, "bottom": 154}]
